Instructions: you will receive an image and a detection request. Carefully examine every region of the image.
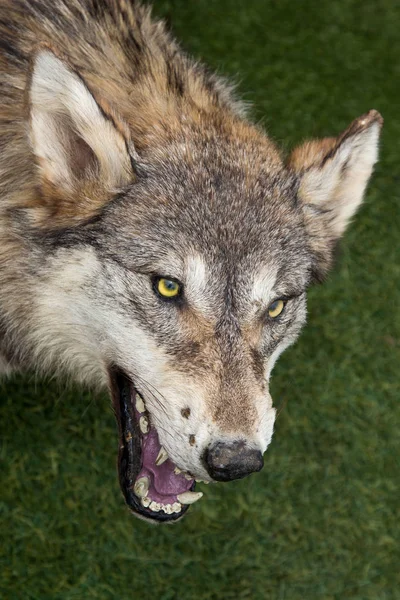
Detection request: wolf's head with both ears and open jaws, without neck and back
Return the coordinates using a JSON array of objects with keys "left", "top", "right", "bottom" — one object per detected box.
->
[{"left": 18, "top": 48, "right": 382, "bottom": 520}]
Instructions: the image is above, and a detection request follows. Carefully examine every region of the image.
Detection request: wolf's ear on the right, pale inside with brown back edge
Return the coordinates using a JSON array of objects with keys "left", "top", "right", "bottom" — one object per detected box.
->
[{"left": 289, "top": 110, "right": 383, "bottom": 279}]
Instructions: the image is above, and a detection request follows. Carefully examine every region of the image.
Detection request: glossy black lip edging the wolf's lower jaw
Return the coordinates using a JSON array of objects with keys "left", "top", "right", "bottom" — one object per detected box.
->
[{"left": 109, "top": 368, "right": 194, "bottom": 523}]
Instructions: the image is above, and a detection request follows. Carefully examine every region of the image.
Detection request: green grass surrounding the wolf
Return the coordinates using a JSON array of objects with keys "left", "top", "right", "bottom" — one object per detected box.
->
[{"left": 0, "top": 0, "right": 400, "bottom": 600}]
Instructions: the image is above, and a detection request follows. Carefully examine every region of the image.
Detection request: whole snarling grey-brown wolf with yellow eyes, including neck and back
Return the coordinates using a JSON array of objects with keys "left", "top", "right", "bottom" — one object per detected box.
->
[{"left": 0, "top": 0, "right": 383, "bottom": 522}]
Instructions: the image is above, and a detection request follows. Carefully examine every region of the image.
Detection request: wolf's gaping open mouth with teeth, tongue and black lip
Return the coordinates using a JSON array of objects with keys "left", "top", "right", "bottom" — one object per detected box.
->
[{"left": 110, "top": 370, "right": 202, "bottom": 523}]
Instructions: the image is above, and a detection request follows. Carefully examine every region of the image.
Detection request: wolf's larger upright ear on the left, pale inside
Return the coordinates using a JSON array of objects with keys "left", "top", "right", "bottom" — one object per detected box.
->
[{"left": 29, "top": 48, "right": 134, "bottom": 222}]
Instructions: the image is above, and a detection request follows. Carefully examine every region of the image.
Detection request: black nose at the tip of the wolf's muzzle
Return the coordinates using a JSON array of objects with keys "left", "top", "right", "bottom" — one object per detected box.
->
[{"left": 203, "top": 441, "right": 264, "bottom": 481}]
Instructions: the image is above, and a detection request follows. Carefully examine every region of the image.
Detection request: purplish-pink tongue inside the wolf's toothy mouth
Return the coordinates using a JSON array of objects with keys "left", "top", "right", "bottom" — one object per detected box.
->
[{"left": 137, "top": 427, "right": 194, "bottom": 504}]
